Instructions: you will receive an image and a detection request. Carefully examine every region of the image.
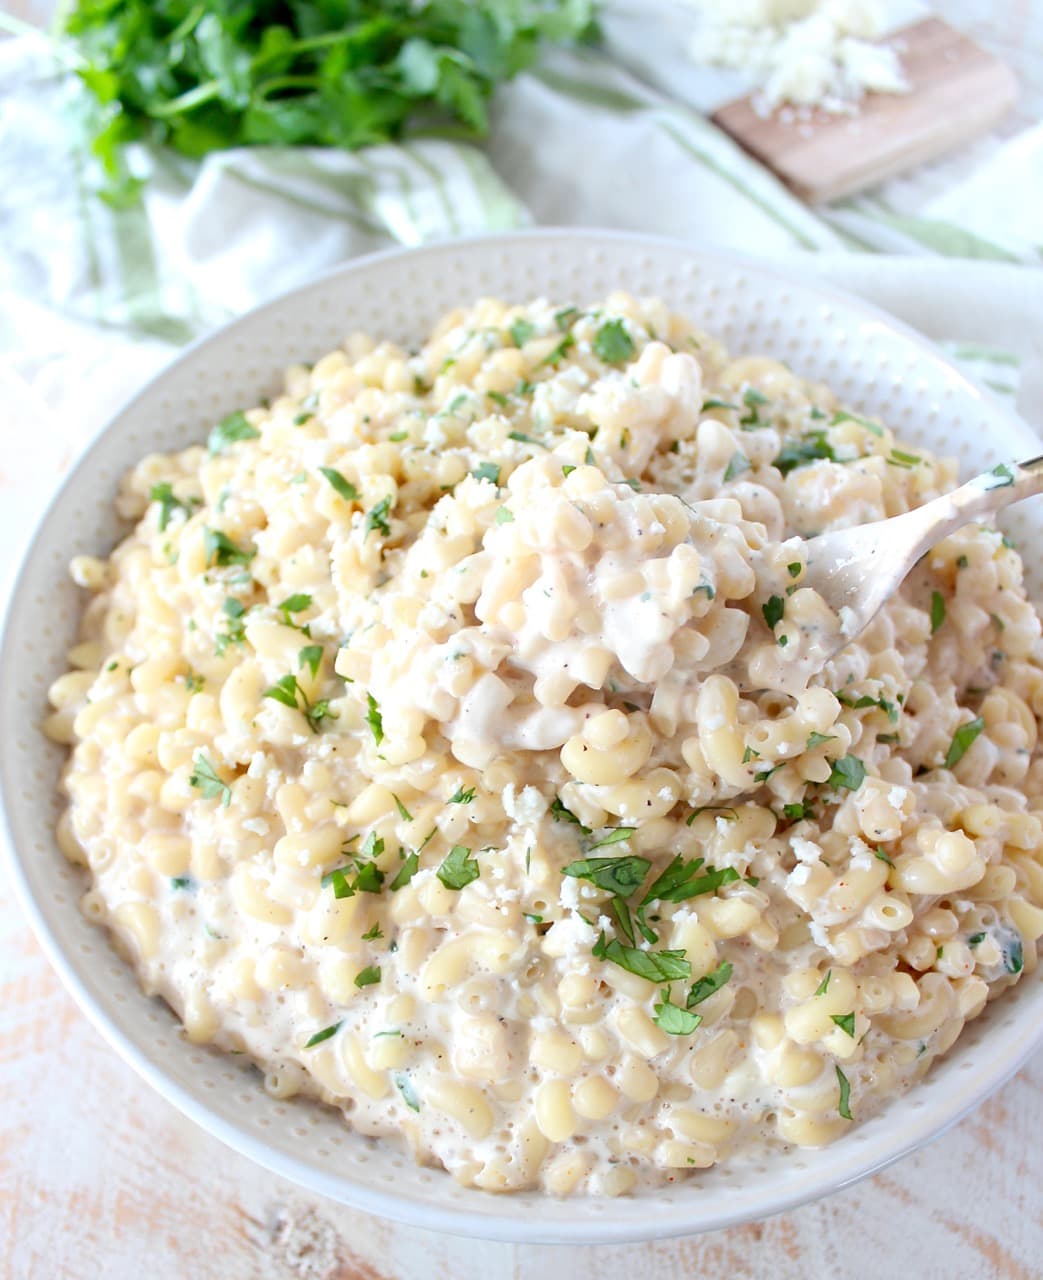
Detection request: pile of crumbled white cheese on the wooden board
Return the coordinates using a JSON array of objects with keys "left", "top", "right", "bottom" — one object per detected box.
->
[{"left": 689, "top": 0, "right": 909, "bottom": 115}]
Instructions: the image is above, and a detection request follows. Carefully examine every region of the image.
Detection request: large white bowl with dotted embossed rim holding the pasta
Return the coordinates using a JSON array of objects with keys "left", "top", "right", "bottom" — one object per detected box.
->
[{"left": 0, "top": 230, "right": 1043, "bottom": 1244}]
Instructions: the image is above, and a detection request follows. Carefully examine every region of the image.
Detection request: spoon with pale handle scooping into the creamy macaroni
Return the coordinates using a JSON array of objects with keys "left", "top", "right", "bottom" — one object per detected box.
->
[{"left": 801, "top": 456, "right": 1043, "bottom": 666}]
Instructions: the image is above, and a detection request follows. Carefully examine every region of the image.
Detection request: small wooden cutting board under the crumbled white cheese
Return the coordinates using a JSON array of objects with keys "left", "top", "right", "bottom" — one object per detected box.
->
[{"left": 713, "top": 18, "right": 1017, "bottom": 204}]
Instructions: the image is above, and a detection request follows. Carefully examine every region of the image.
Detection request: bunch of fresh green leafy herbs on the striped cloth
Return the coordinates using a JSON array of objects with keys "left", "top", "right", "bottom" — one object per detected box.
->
[{"left": 63, "top": 0, "right": 596, "bottom": 202}]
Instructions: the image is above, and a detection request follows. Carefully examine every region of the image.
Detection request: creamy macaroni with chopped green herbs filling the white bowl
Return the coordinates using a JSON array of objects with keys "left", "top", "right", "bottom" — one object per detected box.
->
[{"left": 45, "top": 294, "right": 1043, "bottom": 1196}]
